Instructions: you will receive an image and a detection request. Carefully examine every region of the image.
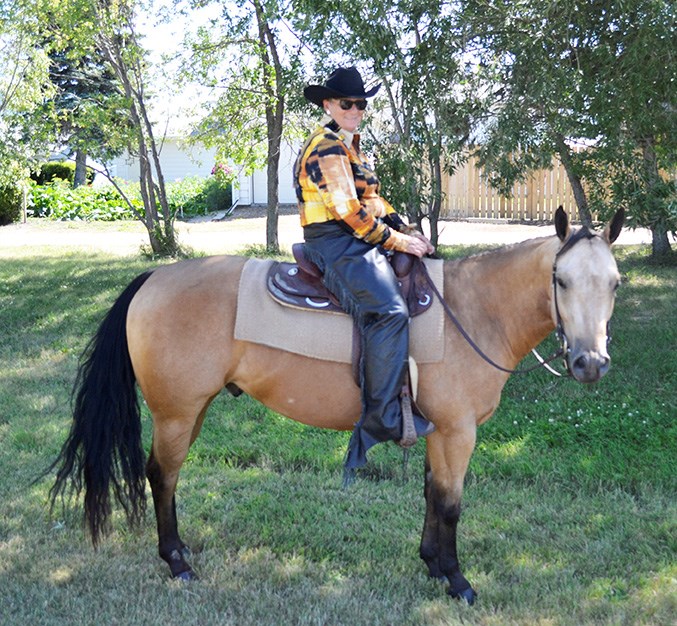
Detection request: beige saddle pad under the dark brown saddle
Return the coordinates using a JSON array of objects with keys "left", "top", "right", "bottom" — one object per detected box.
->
[{"left": 234, "top": 259, "right": 444, "bottom": 363}]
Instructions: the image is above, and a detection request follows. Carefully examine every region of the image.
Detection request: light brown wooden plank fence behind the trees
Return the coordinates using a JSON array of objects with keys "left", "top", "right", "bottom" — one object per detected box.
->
[{"left": 440, "top": 157, "right": 578, "bottom": 222}]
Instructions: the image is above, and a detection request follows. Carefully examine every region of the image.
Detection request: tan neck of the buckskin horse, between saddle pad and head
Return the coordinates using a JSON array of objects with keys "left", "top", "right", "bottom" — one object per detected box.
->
[{"left": 445, "top": 237, "right": 559, "bottom": 367}]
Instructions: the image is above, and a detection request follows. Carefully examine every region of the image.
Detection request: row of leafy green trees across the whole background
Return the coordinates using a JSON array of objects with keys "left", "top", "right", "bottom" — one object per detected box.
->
[{"left": 0, "top": 0, "right": 677, "bottom": 254}]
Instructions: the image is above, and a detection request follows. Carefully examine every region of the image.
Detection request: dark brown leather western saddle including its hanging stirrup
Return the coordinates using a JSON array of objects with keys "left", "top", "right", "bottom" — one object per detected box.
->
[{"left": 266, "top": 243, "right": 433, "bottom": 448}]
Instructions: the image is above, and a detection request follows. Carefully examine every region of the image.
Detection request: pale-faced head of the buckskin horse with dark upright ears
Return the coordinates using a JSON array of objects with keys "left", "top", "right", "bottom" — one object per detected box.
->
[{"left": 552, "top": 207, "right": 624, "bottom": 383}]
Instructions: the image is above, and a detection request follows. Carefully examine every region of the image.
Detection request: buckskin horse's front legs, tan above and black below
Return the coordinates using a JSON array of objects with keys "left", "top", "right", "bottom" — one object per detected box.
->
[{"left": 420, "top": 429, "right": 477, "bottom": 604}]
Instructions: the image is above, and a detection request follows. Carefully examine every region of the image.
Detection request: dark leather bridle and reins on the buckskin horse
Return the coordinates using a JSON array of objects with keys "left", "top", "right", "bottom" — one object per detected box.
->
[{"left": 421, "top": 226, "right": 611, "bottom": 376}]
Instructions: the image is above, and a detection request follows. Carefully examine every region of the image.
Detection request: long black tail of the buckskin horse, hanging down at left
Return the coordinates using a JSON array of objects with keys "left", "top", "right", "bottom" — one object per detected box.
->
[{"left": 50, "top": 272, "right": 152, "bottom": 546}]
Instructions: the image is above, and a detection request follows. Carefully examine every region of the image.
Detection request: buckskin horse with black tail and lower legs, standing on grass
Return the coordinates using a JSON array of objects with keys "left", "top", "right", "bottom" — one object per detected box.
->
[{"left": 50, "top": 207, "right": 623, "bottom": 604}]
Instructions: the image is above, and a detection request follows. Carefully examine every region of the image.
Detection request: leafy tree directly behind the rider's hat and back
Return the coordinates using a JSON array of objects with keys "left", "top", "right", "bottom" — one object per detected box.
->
[{"left": 299, "top": 0, "right": 476, "bottom": 243}]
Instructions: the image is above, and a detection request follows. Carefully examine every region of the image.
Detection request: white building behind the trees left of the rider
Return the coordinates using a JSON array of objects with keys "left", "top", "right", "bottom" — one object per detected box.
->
[{"left": 109, "top": 137, "right": 298, "bottom": 206}]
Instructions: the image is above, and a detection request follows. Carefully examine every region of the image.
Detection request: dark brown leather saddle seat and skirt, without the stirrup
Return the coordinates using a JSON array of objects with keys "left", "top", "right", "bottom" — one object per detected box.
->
[{"left": 267, "top": 243, "right": 433, "bottom": 317}]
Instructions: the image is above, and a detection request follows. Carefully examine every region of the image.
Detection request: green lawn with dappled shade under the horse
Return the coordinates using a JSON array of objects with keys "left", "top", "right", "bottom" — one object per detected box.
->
[{"left": 0, "top": 230, "right": 677, "bottom": 626}]
